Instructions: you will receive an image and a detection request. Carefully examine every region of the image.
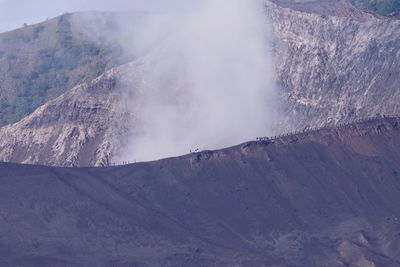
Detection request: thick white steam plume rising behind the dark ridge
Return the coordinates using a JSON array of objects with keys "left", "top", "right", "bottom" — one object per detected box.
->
[{"left": 122, "top": 0, "right": 276, "bottom": 161}]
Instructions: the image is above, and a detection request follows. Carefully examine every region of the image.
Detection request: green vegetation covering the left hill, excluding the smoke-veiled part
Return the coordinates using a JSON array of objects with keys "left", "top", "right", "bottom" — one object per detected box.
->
[{"left": 0, "top": 14, "right": 134, "bottom": 126}]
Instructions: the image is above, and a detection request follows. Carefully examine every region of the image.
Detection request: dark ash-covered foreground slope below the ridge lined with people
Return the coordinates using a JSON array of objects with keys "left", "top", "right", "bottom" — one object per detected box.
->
[{"left": 0, "top": 117, "right": 400, "bottom": 266}]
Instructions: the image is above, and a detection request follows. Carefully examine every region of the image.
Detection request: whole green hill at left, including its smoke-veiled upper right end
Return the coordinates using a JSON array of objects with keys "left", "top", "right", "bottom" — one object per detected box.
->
[{"left": 0, "top": 12, "right": 148, "bottom": 126}]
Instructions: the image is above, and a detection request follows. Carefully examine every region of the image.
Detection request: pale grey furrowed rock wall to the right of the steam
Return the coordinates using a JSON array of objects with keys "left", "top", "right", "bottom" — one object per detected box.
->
[{"left": 266, "top": 2, "right": 400, "bottom": 128}]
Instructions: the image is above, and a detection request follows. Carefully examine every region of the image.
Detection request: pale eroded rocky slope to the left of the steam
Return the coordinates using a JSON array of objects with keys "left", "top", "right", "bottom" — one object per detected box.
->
[{"left": 0, "top": 62, "right": 138, "bottom": 166}]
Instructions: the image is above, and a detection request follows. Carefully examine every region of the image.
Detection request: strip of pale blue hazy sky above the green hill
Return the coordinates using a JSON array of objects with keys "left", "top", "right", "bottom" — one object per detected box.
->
[{"left": 0, "top": 0, "right": 188, "bottom": 32}]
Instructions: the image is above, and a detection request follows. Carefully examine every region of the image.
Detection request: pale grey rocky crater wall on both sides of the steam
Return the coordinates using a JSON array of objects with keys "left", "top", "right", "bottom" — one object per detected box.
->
[{"left": 0, "top": 2, "right": 400, "bottom": 166}]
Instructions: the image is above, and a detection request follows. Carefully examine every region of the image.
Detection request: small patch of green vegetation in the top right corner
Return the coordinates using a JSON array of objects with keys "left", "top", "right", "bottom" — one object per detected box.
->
[{"left": 349, "top": 0, "right": 400, "bottom": 15}]
